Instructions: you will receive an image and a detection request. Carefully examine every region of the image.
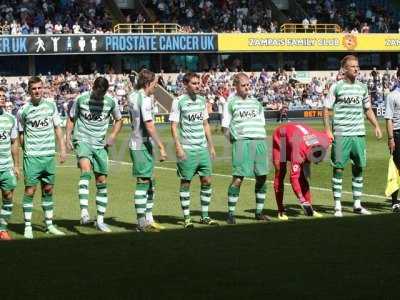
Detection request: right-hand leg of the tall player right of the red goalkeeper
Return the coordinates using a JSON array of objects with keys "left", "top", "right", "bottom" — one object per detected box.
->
[{"left": 350, "top": 137, "right": 371, "bottom": 215}]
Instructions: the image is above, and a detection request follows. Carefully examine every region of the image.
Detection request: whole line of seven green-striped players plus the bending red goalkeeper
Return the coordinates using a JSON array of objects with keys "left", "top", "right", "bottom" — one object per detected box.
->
[{"left": 0, "top": 55, "right": 388, "bottom": 239}]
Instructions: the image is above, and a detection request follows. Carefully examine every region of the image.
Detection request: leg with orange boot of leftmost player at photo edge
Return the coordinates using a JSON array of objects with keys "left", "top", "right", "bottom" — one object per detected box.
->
[{"left": 0, "top": 171, "right": 17, "bottom": 240}]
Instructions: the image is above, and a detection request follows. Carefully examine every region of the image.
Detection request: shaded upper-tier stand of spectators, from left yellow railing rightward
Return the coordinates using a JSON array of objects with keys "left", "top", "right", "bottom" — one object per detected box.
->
[{"left": 128, "top": 0, "right": 399, "bottom": 33}]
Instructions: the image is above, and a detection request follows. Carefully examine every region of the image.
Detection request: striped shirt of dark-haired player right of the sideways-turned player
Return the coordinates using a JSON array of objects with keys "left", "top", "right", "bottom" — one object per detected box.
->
[{"left": 169, "top": 95, "right": 208, "bottom": 150}]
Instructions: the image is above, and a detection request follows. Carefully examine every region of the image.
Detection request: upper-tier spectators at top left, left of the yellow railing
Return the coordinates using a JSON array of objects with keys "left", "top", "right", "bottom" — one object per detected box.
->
[{"left": 0, "top": 0, "right": 112, "bottom": 35}]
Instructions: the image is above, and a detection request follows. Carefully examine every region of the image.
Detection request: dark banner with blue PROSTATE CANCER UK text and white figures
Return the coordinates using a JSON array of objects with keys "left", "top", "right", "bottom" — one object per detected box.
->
[{"left": 0, "top": 34, "right": 218, "bottom": 55}]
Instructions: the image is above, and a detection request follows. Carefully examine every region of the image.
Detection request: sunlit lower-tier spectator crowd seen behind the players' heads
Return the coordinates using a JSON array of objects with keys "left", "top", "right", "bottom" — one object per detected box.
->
[{"left": 0, "top": 68, "right": 397, "bottom": 116}]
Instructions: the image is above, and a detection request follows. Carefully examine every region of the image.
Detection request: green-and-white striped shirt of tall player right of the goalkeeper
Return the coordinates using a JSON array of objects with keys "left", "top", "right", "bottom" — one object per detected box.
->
[{"left": 324, "top": 80, "right": 371, "bottom": 136}]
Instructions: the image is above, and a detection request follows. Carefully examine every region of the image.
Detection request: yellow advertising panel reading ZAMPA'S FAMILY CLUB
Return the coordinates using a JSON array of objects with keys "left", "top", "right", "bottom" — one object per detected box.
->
[{"left": 218, "top": 33, "right": 400, "bottom": 52}]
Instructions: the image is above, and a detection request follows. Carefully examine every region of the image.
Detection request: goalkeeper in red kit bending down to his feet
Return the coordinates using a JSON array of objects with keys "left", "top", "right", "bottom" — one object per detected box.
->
[{"left": 272, "top": 123, "right": 330, "bottom": 220}]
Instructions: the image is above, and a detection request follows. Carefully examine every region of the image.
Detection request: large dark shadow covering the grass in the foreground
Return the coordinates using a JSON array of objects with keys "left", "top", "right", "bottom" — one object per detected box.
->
[{"left": 0, "top": 214, "right": 400, "bottom": 299}]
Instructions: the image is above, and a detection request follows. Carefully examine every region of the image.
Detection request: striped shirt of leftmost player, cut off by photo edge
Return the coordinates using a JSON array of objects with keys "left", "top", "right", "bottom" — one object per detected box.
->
[{"left": 0, "top": 110, "right": 18, "bottom": 172}]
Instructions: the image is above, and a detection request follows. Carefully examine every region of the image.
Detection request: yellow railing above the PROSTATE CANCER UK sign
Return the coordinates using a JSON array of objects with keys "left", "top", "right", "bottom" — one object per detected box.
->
[{"left": 114, "top": 23, "right": 182, "bottom": 33}]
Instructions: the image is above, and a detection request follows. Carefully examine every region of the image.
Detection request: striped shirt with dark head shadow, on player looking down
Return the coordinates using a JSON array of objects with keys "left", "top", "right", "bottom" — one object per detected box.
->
[{"left": 69, "top": 92, "right": 121, "bottom": 149}]
